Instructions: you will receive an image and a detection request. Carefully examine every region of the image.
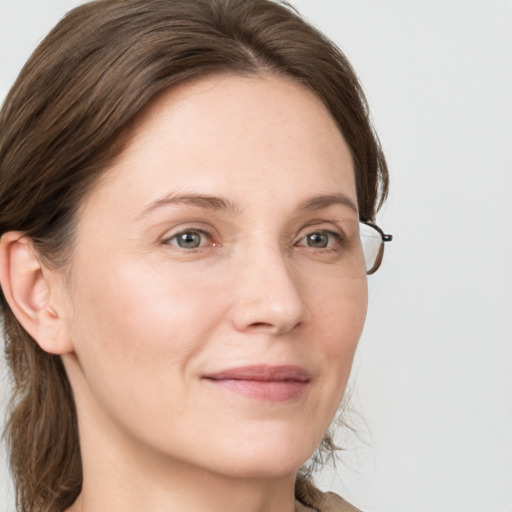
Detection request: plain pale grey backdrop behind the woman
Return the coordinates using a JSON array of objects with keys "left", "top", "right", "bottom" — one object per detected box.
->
[{"left": 0, "top": 0, "right": 512, "bottom": 512}]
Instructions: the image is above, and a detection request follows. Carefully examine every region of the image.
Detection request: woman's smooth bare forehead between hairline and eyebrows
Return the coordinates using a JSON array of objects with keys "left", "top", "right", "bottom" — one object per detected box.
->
[{"left": 81, "top": 75, "right": 355, "bottom": 220}]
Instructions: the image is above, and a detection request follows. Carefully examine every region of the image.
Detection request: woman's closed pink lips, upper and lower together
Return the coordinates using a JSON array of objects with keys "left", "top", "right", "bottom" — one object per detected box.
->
[{"left": 203, "top": 364, "right": 310, "bottom": 402}]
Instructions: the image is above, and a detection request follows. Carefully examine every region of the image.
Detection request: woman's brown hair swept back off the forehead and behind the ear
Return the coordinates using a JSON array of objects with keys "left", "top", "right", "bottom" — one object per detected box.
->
[{"left": 0, "top": 0, "right": 388, "bottom": 512}]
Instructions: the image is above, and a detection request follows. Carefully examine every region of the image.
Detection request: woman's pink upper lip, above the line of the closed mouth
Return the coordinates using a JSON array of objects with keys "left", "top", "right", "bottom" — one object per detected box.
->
[{"left": 204, "top": 364, "right": 310, "bottom": 382}]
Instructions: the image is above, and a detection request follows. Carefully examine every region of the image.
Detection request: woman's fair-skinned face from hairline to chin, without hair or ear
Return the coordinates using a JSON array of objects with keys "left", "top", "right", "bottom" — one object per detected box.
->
[{"left": 61, "top": 76, "right": 367, "bottom": 477}]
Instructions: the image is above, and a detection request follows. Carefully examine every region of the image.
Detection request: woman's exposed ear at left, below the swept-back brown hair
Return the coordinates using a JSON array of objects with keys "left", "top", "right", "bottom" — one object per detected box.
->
[{"left": 0, "top": 231, "right": 73, "bottom": 354}]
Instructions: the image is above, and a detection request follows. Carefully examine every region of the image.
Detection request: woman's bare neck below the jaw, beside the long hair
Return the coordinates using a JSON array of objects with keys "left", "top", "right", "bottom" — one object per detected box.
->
[{"left": 68, "top": 406, "right": 296, "bottom": 512}]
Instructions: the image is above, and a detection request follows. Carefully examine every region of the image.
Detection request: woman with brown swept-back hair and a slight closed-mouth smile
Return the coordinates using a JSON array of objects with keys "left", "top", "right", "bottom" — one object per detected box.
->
[{"left": 0, "top": 0, "right": 390, "bottom": 512}]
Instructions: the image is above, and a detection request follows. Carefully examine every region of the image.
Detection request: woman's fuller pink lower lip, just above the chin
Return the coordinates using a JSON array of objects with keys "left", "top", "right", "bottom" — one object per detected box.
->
[{"left": 207, "top": 379, "right": 308, "bottom": 402}]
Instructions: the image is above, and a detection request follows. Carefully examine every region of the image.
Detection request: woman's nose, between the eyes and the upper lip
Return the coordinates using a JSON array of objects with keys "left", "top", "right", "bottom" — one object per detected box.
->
[{"left": 231, "top": 241, "right": 310, "bottom": 334}]
